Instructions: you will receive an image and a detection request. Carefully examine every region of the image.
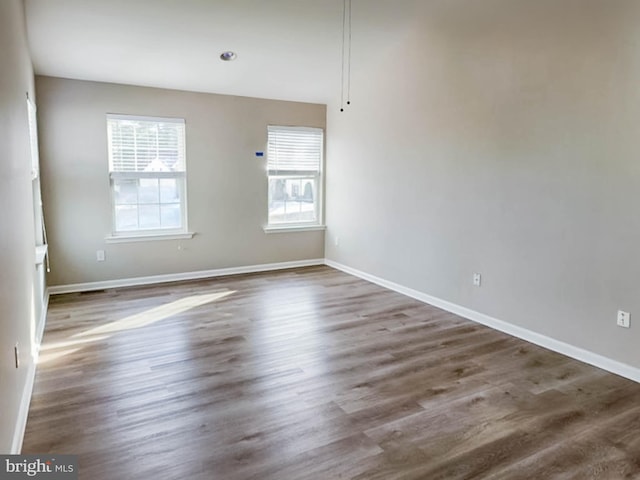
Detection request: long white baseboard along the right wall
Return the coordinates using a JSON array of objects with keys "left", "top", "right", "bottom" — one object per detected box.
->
[{"left": 325, "top": 260, "right": 640, "bottom": 382}]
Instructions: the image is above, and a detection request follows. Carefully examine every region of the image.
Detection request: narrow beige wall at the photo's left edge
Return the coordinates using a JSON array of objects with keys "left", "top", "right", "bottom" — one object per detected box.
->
[{"left": 0, "top": 0, "right": 40, "bottom": 453}]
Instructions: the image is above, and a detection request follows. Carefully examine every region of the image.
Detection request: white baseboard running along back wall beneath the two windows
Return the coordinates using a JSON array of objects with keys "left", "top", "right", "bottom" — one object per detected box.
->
[{"left": 49, "top": 258, "right": 324, "bottom": 295}]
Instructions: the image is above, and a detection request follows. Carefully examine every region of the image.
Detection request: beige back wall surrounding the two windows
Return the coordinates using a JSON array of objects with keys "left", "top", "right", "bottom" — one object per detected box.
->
[{"left": 36, "top": 77, "right": 326, "bottom": 285}]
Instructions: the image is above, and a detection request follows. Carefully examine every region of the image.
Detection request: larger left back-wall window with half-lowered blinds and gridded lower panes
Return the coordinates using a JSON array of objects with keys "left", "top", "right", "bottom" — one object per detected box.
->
[{"left": 107, "top": 115, "right": 187, "bottom": 236}]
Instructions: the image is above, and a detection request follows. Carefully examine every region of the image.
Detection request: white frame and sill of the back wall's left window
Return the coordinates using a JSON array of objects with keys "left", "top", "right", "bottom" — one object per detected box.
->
[{"left": 106, "top": 113, "right": 193, "bottom": 243}]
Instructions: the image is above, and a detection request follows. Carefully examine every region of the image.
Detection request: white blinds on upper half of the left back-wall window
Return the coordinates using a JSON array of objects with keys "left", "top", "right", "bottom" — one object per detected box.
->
[{"left": 107, "top": 115, "right": 185, "bottom": 173}]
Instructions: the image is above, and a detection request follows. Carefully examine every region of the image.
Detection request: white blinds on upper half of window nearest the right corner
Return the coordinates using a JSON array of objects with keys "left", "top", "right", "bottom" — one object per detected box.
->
[{"left": 267, "top": 126, "right": 323, "bottom": 175}]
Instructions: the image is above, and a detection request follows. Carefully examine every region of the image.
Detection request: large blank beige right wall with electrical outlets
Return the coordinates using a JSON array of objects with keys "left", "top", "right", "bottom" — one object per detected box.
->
[{"left": 326, "top": 0, "right": 640, "bottom": 367}]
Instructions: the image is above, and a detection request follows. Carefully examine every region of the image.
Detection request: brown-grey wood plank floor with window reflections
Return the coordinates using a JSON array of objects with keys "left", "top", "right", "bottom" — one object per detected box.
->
[{"left": 23, "top": 267, "right": 640, "bottom": 480}]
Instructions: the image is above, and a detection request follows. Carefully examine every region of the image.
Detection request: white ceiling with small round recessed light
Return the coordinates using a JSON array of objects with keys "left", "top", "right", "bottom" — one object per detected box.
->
[{"left": 25, "top": 0, "right": 356, "bottom": 103}]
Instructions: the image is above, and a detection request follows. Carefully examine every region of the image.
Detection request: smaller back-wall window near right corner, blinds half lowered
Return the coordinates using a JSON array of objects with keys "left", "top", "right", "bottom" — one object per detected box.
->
[{"left": 267, "top": 126, "right": 323, "bottom": 227}]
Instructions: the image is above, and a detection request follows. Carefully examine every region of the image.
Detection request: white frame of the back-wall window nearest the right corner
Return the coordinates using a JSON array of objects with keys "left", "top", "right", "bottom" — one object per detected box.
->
[{"left": 264, "top": 125, "right": 325, "bottom": 233}]
